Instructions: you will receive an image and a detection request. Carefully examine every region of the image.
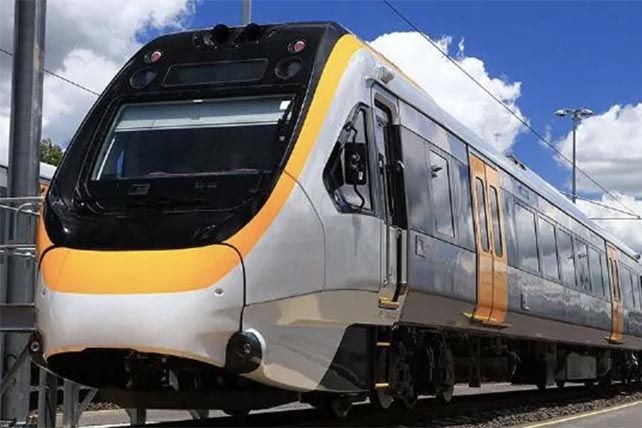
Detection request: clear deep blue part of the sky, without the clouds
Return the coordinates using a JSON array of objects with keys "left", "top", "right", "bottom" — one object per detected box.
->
[{"left": 170, "top": 0, "right": 642, "bottom": 196}]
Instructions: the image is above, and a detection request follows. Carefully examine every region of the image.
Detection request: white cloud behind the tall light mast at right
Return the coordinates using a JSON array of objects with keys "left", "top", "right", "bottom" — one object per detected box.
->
[{"left": 557, "top": 103, "right": 642, "bottom": 196}]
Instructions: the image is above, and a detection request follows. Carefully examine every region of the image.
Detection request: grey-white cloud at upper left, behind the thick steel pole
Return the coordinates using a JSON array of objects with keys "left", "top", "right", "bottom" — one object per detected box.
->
[{"left": 0, "top": 0, "right": 194, "bottom": 160}]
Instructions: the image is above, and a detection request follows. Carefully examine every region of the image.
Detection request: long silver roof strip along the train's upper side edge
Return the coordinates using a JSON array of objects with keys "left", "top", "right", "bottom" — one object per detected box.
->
[{"left": 348, "top": 25, "right": 639, "bottom": 258}]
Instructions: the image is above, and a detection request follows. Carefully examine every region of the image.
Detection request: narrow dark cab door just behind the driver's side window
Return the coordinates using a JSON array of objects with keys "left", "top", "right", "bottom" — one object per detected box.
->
[{"left": 374, "top": 102, "right": 407, "bottom": 309}]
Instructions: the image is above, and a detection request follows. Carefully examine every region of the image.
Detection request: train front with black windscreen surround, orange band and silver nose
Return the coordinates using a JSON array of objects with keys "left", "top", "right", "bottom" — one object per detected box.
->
[{"left": 36, "top": 24, "right": 356, "bottom": 402}]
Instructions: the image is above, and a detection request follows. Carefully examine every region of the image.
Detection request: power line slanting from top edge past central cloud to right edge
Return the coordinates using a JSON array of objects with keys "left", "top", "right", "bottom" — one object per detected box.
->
[{"left": 381, "top": 0, "right": 639, "bottom": 217}]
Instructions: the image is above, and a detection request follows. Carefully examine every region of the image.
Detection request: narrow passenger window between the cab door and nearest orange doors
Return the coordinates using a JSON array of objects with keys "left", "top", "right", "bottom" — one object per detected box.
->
[{"left": 428, "top": 150, "right": 454, "bottom": 236}]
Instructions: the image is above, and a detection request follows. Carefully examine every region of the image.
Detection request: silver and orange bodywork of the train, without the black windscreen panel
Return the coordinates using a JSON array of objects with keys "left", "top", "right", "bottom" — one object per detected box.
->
[{"left": 36, "top": 24, "right": 642, "bottom": 407}]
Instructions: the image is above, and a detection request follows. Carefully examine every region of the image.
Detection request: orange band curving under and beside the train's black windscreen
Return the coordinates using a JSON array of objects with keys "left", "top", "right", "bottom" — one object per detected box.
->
[{"left": 38, "top": 34, "right": 364, "bottom": 294}]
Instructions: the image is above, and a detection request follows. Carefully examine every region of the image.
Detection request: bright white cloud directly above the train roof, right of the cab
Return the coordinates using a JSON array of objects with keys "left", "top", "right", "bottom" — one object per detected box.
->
[{"left": 370, "top": 32, "right": 523, "bottom": 151}]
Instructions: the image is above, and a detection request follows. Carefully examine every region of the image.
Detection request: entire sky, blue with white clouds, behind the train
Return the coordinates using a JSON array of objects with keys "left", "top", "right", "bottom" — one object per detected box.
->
[{"left": 0, "top": 0, "right": 642, "bottom": 250}]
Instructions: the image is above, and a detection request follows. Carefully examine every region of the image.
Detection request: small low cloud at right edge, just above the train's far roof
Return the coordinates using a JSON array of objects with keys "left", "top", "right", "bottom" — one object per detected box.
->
[{"left": 577, "top": 193, "right": 642, "bottom": 252}]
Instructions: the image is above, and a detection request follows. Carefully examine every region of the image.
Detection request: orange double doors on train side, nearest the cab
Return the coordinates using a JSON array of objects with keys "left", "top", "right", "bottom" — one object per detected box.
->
[{"left": 467, "top": 154, "right": 508, "bottom": 327}]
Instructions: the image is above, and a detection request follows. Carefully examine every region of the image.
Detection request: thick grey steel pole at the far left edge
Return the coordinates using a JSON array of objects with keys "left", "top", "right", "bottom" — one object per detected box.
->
[{"left": 0, "top": 0, "right": 47, "bottom": 424}]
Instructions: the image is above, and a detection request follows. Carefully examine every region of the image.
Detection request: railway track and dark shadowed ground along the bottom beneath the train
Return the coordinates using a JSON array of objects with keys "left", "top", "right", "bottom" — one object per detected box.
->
[{"left": 152, "top": 385, "right": 642, "bottom": 427}]
